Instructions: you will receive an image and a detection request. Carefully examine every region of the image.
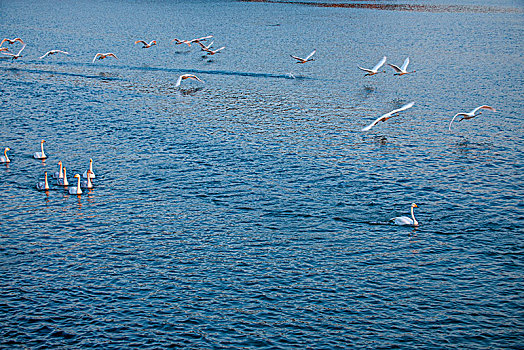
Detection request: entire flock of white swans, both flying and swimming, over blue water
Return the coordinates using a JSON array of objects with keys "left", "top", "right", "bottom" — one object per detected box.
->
[{"left": 0, "top": 35, "right": 495, "bottom": 226}]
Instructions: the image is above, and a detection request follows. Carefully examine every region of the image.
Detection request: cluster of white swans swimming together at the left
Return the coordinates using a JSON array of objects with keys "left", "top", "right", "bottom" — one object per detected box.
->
[{"left": 0, "top": 140, "right": 96, "bottom": 195}]
